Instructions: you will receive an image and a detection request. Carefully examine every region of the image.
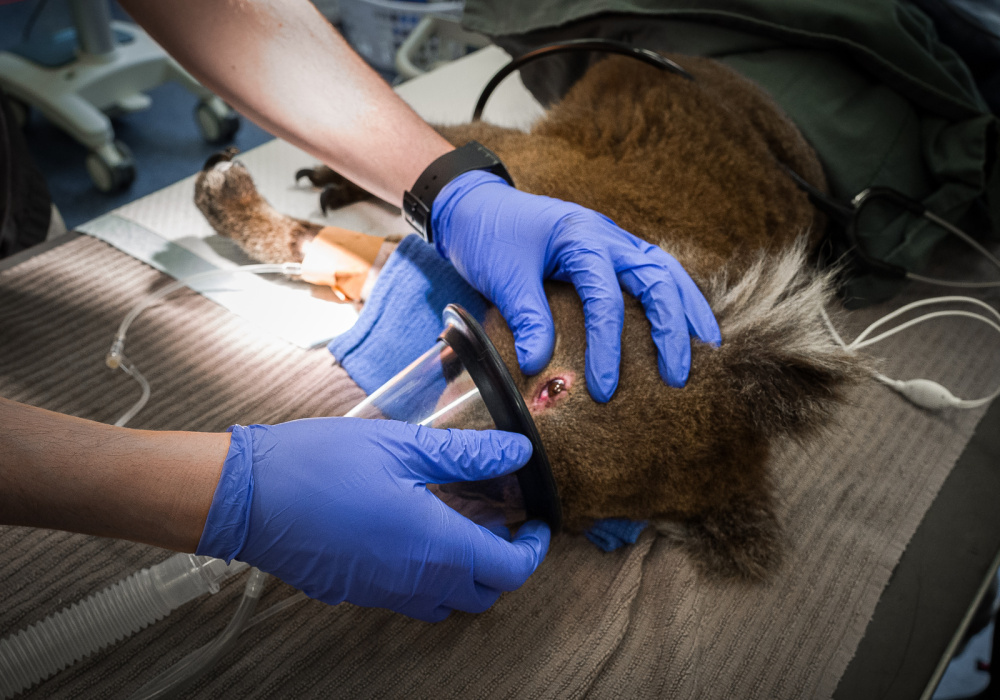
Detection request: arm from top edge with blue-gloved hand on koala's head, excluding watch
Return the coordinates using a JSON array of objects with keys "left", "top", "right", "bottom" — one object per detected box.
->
[{"left": 122, "top": 0, "right": 721, "bottom": 402}]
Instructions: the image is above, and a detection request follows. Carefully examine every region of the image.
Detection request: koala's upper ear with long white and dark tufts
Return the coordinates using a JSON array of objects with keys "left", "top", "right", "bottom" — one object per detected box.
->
[{"left": 711, "top": 238, "right": 863, "bottom": 438}]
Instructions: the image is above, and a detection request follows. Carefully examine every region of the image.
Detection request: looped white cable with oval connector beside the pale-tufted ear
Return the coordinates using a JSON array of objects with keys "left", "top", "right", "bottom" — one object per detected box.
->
[{"left": 820, "top": 296, "right": 1000, "bottom": 411}]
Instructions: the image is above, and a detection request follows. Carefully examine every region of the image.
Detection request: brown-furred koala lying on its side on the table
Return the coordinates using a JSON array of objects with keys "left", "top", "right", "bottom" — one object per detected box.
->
[{"left": 195, "top": 56, "right": 863, "bottom": 580}]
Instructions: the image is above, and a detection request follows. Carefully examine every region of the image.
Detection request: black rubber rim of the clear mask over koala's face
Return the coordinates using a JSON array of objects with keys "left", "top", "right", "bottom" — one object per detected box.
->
[{"left": 438, "top": 304, "right": 562, "bottom": 532}]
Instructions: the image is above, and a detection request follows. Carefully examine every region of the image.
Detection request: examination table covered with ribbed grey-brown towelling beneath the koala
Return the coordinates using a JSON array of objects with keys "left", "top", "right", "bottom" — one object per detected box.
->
[{"left": 0, "top": 49, "right": 1000, "bottom": 700}]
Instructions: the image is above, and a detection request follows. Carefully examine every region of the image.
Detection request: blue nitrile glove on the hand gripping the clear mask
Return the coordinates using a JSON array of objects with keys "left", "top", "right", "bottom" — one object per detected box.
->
[{"left": 197, "top": 418, "right": 549, "bottom": 622}]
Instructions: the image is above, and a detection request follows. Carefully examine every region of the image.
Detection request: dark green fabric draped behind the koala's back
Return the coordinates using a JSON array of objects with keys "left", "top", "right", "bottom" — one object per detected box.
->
[{"left": 463, "top": 0, "right": 1000, "bottom": 301}]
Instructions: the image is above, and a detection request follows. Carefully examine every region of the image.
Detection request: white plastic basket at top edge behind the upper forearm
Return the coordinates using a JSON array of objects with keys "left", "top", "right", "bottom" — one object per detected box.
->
[{"left": 340, "top": 0, "right": 464, "bottom": 71}]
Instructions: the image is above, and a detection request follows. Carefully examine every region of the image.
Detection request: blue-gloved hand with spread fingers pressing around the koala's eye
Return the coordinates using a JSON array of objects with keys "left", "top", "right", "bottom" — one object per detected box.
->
[{"left": 431, "top": 170, "right": 721, "bottom": 402}]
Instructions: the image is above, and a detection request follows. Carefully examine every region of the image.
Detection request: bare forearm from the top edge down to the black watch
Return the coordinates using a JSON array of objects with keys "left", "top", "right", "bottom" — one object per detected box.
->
[{"left": 121, "top": 0, "right": 452, "bottom": 205}]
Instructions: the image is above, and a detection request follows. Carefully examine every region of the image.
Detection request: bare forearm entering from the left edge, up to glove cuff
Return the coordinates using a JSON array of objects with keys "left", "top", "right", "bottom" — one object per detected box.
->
[{"left": 0, "top": 398, "right": 229, "bottom": 552}]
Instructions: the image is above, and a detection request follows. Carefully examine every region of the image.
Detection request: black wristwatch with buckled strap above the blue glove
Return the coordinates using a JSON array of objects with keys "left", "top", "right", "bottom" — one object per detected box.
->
[{"left": 403, "top": 141, "right": 514, "bottom": 243}]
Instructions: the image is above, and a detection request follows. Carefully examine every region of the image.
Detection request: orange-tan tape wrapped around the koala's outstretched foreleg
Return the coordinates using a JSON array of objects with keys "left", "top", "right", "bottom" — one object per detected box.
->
[{"left": 302, "top": 226, "right": 384, "bottom": 301}]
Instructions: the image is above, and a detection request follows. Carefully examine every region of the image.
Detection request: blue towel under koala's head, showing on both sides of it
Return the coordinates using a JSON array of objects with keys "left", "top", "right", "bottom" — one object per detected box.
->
[{"left": 327, "top": 236, "right": 646, "bottom": 552}]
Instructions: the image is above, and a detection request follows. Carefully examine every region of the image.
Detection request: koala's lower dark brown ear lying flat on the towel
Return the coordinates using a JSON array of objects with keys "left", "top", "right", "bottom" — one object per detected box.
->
[{"left": 652, "top": 491, "right": 783, "bottom": 581}]
